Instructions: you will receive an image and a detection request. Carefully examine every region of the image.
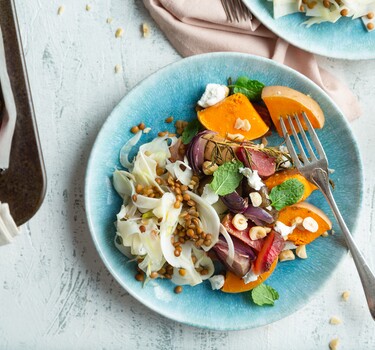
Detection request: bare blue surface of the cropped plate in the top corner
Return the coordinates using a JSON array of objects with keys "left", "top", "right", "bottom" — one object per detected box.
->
[{"left": 243, "top": 0, "right": 375, "bottom": 60}]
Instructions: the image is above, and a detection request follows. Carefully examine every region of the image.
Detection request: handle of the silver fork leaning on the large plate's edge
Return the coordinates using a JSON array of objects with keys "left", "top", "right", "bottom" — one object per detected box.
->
[{"left": 311, "top": 168, "right": 375, "bottom": 320}]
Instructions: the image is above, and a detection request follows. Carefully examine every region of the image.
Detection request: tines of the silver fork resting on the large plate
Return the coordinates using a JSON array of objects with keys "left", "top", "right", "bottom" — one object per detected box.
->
[{"left": 280, "top": 112, "right": 326, "bottom": 168}]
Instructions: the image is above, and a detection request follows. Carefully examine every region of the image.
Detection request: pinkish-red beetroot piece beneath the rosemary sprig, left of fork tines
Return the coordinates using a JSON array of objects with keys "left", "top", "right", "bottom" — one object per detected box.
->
[{"left": 236, "top": 147, "right": 276, "bottom": 177}]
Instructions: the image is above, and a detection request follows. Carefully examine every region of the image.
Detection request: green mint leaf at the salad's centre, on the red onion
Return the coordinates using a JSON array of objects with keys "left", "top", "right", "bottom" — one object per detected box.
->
[{"left": 210, "top": 161, "right": 243, "bottom": 196}]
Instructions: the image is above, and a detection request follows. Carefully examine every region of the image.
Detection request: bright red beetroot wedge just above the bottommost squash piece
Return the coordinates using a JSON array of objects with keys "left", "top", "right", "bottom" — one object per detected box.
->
[{"left": 253, "top": 230, "right": 285, "bottom": 275}]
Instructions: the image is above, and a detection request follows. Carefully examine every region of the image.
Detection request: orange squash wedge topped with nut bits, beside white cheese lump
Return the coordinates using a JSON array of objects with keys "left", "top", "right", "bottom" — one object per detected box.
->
[{"left": 198, "top": 93, "right": 269, "bottom": 141}]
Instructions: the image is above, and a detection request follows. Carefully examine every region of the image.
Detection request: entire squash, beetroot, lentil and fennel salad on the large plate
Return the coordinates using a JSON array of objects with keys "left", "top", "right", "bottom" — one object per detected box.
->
[{"left": 113, "top": 76, "right": 332, "bottom": 305}]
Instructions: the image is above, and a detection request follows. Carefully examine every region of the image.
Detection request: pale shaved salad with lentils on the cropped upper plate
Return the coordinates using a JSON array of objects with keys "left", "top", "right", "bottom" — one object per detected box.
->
[{"left": 269, "top": 0, "right": 375, "bottom": 31}]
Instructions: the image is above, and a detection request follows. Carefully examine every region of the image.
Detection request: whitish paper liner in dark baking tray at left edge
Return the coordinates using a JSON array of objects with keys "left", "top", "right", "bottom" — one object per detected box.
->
[{"left": 0, "top": 28, "right": 17, "bottom": 171}]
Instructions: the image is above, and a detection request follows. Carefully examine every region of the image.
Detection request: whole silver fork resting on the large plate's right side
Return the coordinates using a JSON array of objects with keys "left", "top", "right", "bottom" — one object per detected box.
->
[{"left": 280, "top": 112, "right": 375, "bottom": 320}]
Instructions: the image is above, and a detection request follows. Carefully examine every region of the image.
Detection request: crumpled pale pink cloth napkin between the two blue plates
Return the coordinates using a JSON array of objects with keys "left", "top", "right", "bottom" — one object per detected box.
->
[{"left": 143, "top": 0, "right": 361, "bottom": 120}]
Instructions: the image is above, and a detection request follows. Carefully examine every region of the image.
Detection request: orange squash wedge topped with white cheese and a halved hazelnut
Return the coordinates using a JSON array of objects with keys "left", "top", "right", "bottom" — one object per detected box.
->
[{"left": 277, "top": 202, "right": 332, "bottom": 246}]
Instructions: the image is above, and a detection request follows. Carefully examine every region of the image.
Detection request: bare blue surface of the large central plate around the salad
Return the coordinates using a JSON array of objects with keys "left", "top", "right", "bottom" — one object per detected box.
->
[{"left": 85, "top": 53, "right": 362, "bottom": 330}]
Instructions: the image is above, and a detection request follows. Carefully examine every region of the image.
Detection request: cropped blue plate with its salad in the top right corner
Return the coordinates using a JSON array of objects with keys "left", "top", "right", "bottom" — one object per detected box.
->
[{"left": 242, "top": 0, "right": 375, "bottom": 60}]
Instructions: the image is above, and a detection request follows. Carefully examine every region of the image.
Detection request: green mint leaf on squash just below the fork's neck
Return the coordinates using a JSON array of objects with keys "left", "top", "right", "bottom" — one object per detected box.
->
[{"left": 269, "top": 179, "right": 305, "bottom": 210}]
